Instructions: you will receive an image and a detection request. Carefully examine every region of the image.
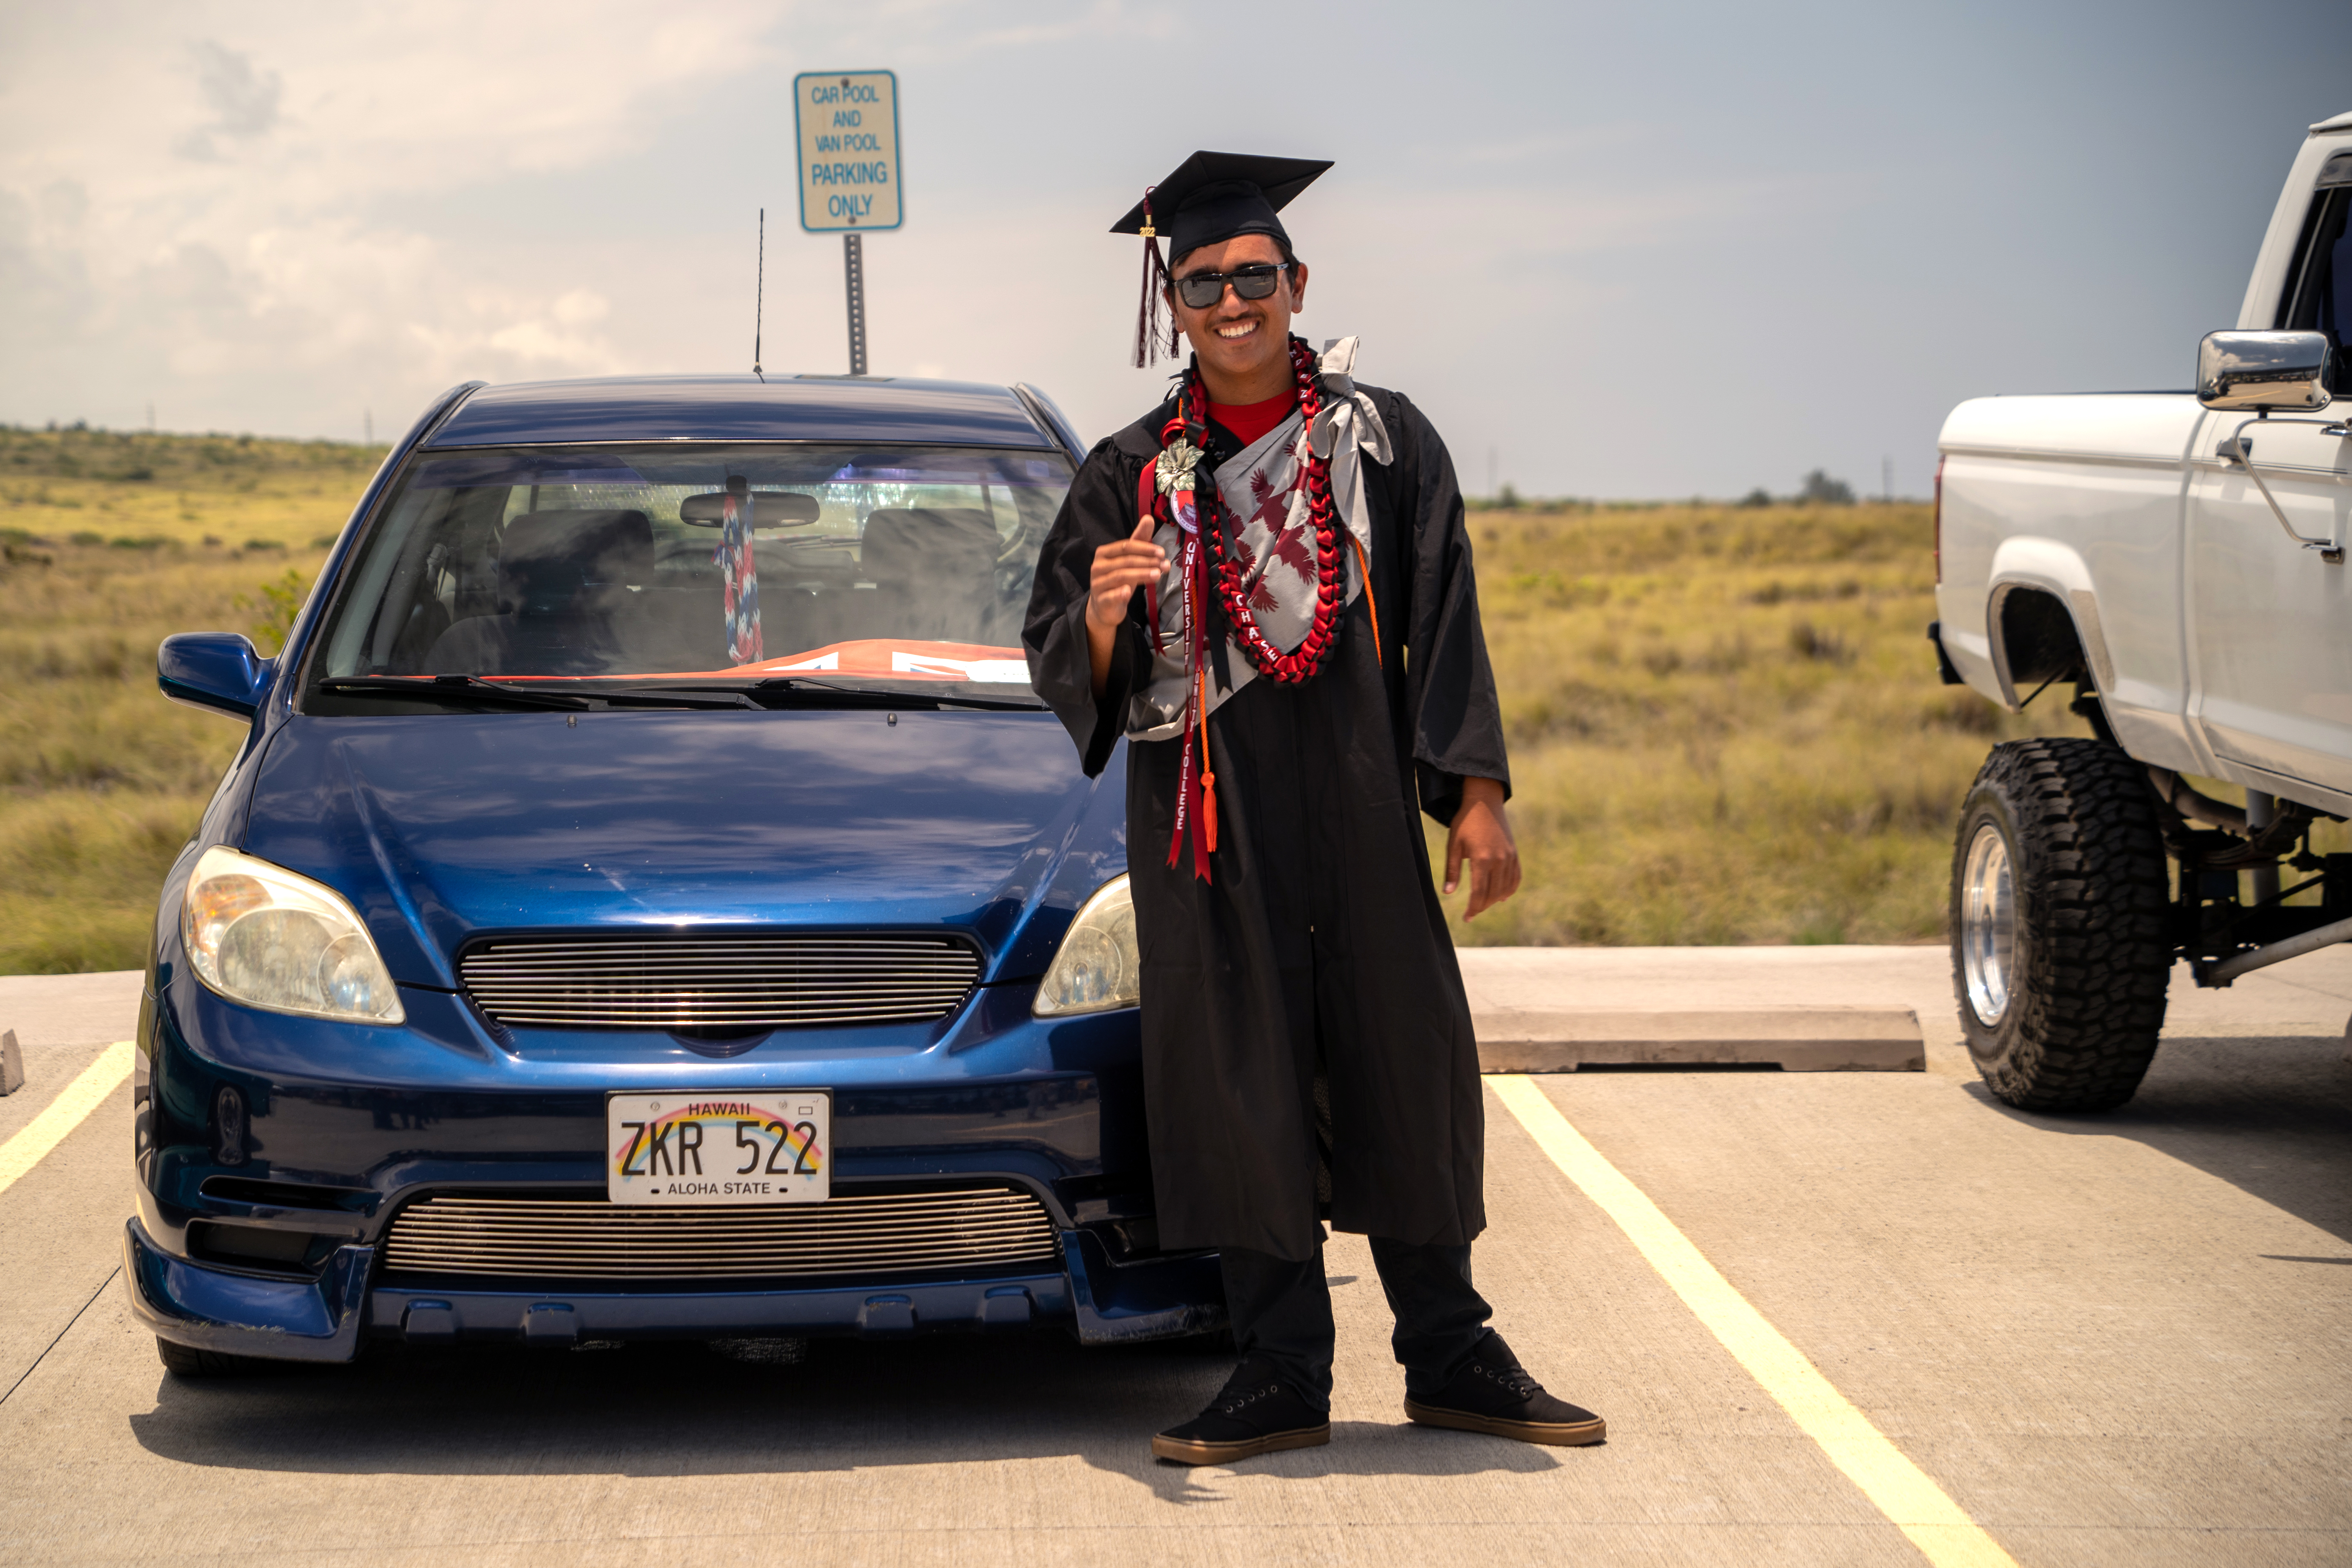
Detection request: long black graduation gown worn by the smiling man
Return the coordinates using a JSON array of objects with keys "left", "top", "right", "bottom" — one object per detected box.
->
[{"left": 1023, "top": 388, "right": 1508, "bottom": 1260}]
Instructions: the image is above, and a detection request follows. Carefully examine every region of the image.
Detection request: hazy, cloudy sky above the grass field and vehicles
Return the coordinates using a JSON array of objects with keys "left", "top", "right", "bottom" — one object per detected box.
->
[{"left": 0, "top": 0, "right": 2352, "bottom": 499}]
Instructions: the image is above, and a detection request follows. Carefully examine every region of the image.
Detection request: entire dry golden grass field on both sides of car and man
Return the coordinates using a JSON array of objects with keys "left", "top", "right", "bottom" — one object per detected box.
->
[{"left": 0, "top": 430, "right": 2239, "bottom": 973}]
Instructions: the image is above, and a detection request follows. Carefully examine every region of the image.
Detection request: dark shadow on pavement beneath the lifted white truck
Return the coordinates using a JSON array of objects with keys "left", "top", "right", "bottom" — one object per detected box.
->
[{"left": 1966, "top": 1034, "right": 2352, "bottom": 1262}]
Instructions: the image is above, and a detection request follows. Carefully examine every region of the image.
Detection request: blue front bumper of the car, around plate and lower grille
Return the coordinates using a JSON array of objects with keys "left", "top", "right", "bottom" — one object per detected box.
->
[{"left": 125, "top": 969, "right": 1223, "bottom": 1361}]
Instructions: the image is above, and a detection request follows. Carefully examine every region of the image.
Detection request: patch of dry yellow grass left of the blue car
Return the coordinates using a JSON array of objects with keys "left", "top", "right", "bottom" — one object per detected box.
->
[{"left": 0, "top": 430, "right": 383, "bottom": 973}]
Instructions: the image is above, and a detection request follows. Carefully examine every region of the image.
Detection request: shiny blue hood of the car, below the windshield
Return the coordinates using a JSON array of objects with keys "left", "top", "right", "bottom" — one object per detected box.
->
[{"left": 242, "top": 710, "right": 1124, "bottom": 987}]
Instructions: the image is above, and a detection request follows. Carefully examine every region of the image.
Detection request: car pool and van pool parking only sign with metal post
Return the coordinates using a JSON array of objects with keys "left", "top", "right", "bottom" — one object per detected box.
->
[{"left": 793, "top": 70, "right": 906, "bottom": 376}]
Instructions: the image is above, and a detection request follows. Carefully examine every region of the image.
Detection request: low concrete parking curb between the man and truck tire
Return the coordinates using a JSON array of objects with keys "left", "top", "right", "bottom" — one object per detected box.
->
[{"left": 1470, "top": 1006, "right": 1926, "bottom": 1072}]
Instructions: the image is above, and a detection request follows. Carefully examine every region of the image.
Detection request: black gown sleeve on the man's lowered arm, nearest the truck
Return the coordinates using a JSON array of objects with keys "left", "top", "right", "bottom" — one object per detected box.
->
[{"left": 1383, "top": 393, "right": 1510, "bottom": 825}]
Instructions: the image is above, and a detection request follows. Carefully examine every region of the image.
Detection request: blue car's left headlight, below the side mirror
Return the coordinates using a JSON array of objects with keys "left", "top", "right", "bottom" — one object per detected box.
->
[{"left": 179, "top": 846, "right": 407, "bottom": 1022}]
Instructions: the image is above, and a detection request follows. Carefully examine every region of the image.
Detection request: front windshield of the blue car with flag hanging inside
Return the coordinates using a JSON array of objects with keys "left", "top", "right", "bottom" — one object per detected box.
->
[{"left": 310, "top": 442, "right": 1070, "bottom": 710}]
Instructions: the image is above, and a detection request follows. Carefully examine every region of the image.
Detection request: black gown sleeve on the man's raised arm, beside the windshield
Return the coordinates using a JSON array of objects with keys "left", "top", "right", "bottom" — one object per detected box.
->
[{"left": 1021, "top": 437, "right": 1150, "bottom": 778}]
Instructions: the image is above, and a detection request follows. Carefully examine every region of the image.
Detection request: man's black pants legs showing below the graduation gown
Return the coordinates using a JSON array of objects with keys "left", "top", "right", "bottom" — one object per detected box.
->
[{"left": 1221, "top": 1237, "right": 1494, "bottom": 1410}]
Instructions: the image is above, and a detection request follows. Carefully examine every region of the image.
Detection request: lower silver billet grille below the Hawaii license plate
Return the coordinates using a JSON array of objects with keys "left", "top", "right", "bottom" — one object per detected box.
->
[{"left": 383, "top": 1187, "right": 1056, "bottom": 1281}]
